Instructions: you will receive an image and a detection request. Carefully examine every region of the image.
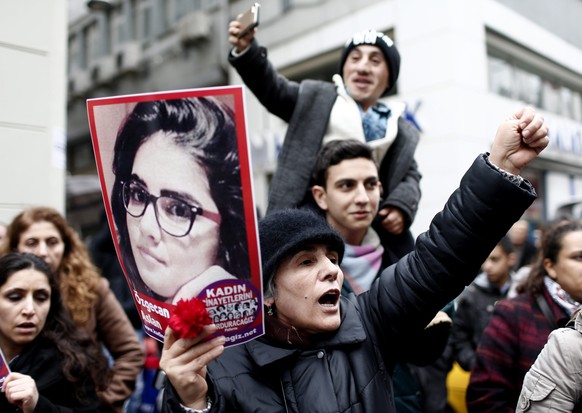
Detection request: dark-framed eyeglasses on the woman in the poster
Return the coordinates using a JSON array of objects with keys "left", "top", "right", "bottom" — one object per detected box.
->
[{"left": 122, "top": 181, "right": 220, "bottom": 237}]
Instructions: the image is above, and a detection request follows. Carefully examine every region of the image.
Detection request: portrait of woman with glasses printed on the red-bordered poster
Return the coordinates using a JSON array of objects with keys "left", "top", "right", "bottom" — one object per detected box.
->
[{"left": 111, "top": 98, "right": 250, "bottom": 303}]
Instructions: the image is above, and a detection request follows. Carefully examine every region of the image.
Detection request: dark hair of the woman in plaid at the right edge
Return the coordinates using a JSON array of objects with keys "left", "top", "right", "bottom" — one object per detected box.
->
[{"left": 517, "top": 221, "right": 582, "bottom": 295}]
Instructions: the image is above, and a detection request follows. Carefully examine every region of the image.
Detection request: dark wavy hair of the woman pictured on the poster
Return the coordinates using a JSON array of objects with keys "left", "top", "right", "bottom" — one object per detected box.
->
[{"left": 111, "top": 97, "right": 250, "bottom": 296}]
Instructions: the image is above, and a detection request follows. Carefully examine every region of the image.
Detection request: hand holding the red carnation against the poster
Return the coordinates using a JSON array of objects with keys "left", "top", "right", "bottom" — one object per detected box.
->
[{"left": 160, "top": 324, "right": 226, "bottom": 410}]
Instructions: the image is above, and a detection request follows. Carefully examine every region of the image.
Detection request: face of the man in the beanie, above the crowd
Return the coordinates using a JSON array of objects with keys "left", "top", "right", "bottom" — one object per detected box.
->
[{"left": 343, "top": 45, "right": 388, "bottom": 110}]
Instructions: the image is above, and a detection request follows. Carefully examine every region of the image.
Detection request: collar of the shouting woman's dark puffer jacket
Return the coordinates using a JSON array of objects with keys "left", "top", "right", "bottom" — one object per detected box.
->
[{"left": 245, "top": 297, "right": 366, "bottom": 367}]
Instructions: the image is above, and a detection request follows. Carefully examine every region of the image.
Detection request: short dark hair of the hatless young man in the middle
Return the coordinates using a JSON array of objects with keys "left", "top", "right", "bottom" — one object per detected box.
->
[{"left": 312, "top": 139, "right": 377, "bottom": 188}]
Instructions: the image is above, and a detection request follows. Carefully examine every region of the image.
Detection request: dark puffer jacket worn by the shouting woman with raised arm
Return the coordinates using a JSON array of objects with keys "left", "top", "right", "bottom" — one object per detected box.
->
[{"left": 162, "top": 156, "right": 535, "bottom": 413}]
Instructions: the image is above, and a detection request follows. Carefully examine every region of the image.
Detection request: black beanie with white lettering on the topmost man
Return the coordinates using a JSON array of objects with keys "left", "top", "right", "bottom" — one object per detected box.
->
[{"left": 339, "top": 30, "right": 400, "bottom": 94}]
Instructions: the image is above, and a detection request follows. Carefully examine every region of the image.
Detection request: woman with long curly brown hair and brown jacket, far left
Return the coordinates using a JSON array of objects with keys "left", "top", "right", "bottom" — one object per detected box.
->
[{"left": 2, "top": 207, "right": 144, "bottom": 412}]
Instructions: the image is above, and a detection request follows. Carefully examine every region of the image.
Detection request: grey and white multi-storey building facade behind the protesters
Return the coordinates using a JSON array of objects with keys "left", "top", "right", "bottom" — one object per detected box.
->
[{"left": 67, "top": 0, "right": 582, "bottom": 238}]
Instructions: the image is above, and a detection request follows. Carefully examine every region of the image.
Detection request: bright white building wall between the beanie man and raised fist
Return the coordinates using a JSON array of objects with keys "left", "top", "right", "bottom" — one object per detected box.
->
[{"left": 404, "top": 0, "right": 582, "bottom": 235}]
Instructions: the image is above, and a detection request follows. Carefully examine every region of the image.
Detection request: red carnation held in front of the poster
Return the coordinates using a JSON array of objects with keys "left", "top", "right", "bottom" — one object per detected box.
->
[{"left": 169, "top": 298, "right": 212, "bottom": 338}]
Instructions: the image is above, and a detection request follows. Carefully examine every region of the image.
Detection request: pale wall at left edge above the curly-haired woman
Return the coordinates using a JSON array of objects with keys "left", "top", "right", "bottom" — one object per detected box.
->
[{"left": 0, "top": 0, "right": 67, "bottom": 225}]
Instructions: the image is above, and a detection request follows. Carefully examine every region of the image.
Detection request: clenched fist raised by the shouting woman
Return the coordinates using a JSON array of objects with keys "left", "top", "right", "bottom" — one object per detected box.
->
[{"left": 489, "top": 107, "right": 549, "bottom": 175}]
